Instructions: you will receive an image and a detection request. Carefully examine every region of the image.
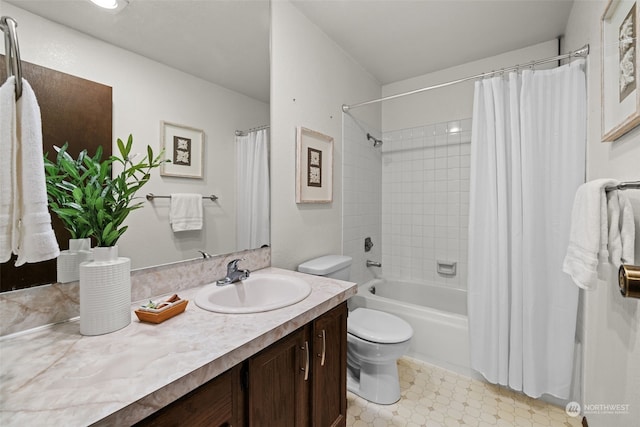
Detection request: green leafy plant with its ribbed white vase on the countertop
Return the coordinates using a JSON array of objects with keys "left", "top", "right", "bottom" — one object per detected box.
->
[{"left": 45, "top": 135, "right": 165, "bottom": 335}]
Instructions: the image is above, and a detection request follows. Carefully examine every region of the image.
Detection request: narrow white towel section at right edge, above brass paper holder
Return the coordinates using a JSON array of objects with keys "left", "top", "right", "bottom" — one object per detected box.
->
[{"left": 607, "top": 191, "right": 636, "bottom": 268}]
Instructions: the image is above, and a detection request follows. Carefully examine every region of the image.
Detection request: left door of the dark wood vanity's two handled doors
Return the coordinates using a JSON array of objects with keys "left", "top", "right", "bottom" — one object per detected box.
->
[{"left": 247, "top": 327, "right": 311, "bottom": 427}]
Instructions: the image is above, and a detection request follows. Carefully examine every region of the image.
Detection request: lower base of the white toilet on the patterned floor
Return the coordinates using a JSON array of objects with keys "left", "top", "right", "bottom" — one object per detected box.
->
[{"left": 347, "top": 361, "right": 400, "bottom": 405}]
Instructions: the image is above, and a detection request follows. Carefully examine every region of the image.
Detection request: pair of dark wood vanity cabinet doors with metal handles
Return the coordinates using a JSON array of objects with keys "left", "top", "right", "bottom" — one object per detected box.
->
[{"left": 246, "top": 303, "right": 347, "bottom": 427}]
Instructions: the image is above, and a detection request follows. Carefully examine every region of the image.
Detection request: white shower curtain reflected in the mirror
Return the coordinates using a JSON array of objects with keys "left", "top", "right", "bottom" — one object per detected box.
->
[{"left": 236, "top": 129, "right": 270, "bottom": 250}]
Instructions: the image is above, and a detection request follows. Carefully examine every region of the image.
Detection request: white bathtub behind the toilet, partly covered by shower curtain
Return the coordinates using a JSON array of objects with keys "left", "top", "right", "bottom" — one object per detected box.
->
[{"left": 349, "top": 279, "right": 477, "bottom": 377}]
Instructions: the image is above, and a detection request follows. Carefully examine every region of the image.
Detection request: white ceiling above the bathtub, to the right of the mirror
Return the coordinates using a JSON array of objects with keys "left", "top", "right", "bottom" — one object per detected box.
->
[{"left": 296, "top": 0, "right": 573, "bottom": 84}]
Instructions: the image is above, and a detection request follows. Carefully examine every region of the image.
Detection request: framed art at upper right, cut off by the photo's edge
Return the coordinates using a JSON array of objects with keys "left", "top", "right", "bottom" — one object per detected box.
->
[{"left": 601, "top": 0, "right": 640, "bottom": 142}]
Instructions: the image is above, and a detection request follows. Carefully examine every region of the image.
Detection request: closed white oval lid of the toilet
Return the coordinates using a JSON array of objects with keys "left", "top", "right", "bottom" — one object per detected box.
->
[{"left": 347, "top": 308, "right": 413, "bottom": 344}]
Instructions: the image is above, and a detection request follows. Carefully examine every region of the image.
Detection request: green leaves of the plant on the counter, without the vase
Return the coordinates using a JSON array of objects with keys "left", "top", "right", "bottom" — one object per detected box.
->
[{"left": 44, "top": 135, "right": 168, "bottom": 247}]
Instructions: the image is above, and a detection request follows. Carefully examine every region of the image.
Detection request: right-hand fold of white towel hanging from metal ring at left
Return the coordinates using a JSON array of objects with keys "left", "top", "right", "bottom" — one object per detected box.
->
[{"left": 13, "top": 79, "right": 60, "bottom": 266}]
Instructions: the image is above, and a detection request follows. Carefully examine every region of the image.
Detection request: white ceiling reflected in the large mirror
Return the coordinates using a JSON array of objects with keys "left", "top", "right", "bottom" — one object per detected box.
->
[{"left": 5, "top": 0, "right": 270, "bottom": 102}]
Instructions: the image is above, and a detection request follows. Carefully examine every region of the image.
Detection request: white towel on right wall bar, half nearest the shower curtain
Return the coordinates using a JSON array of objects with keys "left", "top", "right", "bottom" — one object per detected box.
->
[{"left": 562, "top": 179, "right": 618, "bottom": 289}]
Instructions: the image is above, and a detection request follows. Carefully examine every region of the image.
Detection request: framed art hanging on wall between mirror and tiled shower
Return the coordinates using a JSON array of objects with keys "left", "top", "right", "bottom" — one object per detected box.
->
[{"left": 296, "top": 127, "right": 333, "bottom": 203}]
